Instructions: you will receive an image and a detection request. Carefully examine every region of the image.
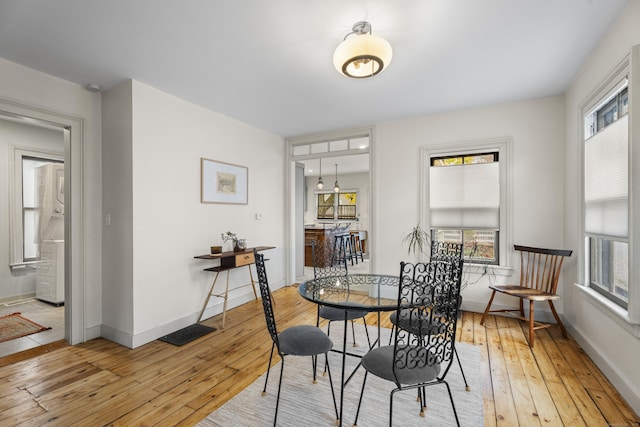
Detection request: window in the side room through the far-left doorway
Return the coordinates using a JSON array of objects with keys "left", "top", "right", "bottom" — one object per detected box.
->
[{"left": 10, "top": 148, "right": 64, "bottom": 266}]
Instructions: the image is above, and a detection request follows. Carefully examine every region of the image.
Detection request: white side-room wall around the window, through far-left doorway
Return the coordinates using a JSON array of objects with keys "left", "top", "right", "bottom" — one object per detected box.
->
[{"left": 0, "top": 116, "right": 64, "bottom": 300}]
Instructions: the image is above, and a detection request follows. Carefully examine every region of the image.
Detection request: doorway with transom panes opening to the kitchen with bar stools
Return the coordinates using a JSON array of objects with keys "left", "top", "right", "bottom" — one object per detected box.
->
[{"left": 286, "top": 128, "right": 375, "bottom": 283}]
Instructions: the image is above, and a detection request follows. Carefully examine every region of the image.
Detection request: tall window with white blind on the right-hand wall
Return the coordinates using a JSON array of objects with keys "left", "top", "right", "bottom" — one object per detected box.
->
[{"left": 584, "top": 77, "right": 629, "bottom": 308}]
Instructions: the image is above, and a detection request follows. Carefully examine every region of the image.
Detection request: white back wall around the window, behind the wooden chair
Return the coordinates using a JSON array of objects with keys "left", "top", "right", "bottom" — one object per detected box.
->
[{"left": 373, "top": 97, "right": 572, "bottom": 310}]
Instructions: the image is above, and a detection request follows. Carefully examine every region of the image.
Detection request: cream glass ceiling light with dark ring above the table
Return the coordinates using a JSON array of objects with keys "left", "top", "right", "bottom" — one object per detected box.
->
[{"left": 333, "top": 21, "right": 392, "bottom": 79}]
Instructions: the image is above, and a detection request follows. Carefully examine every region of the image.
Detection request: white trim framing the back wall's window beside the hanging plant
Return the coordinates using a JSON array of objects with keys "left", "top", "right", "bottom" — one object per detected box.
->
[{"left": 419, "top": 136, "right": 513, "bottom": 267}]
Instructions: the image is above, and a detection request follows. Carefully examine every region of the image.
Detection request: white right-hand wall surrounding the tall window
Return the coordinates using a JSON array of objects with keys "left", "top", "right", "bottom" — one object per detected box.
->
[{"left": 563, "top": 1, "right": 640, "bottom": 413}]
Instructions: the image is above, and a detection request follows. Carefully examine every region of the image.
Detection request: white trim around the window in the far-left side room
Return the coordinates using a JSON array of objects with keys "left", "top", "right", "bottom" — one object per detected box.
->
[{"left": 9, "top": 146, "right": 64, "bottom": 269}]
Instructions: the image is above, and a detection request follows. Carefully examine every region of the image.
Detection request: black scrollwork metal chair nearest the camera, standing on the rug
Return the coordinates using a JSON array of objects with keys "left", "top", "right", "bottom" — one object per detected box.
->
[{"left": 353, "top": 262, "right": 461, "bottom": 426}]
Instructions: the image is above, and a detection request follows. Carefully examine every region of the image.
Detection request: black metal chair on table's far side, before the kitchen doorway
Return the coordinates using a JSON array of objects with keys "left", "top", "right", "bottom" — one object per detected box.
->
[{"left": 311, "top": 240, "right": 371, "bottom": 347}]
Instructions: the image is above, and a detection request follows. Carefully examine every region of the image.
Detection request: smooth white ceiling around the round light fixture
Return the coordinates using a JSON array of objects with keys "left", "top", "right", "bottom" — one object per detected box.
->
[{"left": 0, "top": 0, "right": 633, "bottom": 142}]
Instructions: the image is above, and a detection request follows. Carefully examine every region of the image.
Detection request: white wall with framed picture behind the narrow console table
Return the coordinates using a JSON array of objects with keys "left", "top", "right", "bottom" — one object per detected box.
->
[{"left": 103, "top": 81, "right": 285, "bottom": 347}]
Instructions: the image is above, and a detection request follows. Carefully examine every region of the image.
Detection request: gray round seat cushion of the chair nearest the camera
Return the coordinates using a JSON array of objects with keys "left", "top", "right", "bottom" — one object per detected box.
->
[{"left": 362, "top": 345, "right": 440, "bottom": 384}]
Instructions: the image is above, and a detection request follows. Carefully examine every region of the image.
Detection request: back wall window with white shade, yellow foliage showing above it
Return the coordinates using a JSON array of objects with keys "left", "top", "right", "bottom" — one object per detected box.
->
[{"left": 429, "top": 151, "right": 500, "bottom": 264}]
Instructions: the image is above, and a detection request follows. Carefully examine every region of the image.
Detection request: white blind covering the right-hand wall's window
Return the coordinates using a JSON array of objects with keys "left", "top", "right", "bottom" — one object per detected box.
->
[{"left": 584, "top": 115, "right": 629, "bottom": 237}]
